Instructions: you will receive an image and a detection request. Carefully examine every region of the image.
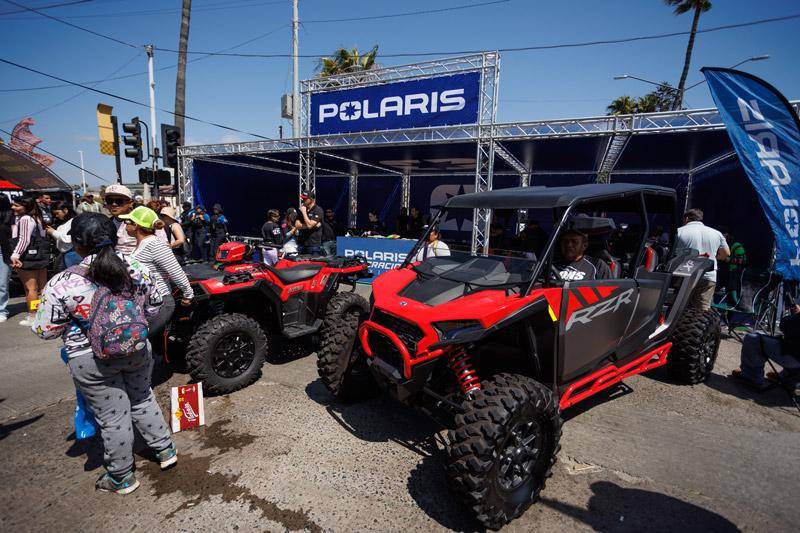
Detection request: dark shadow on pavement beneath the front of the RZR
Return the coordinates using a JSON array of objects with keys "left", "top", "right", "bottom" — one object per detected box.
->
[{"left": 306, "top": 380, "right": 481, "bottom": 531}]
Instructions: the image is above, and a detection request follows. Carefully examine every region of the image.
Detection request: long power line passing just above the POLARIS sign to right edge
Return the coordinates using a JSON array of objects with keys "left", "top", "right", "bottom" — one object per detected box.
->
[{"left": 156, "top": 13, "right": 800, "bottom": 58}]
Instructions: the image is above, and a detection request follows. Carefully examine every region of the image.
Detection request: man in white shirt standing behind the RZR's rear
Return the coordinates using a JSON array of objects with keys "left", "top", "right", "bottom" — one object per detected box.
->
[{"left": 675, "top": 209, "right": 731, "bottom": 310}]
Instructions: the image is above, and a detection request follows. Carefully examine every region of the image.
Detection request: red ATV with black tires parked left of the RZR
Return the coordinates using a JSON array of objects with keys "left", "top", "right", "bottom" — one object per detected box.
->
[{"left": 164, "top": 242, "right": 370, "bottom": 394}]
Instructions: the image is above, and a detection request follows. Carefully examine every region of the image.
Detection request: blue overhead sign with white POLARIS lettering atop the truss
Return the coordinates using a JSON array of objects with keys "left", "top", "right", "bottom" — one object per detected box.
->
[{"left": 309, "top": 72, "right": 481, "bottom": 135}]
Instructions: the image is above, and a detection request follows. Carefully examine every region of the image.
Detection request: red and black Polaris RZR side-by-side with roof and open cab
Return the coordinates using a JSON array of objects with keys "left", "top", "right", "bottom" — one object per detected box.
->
[{"left": 318, "top": 184, "right": 720, "bottom": 528}]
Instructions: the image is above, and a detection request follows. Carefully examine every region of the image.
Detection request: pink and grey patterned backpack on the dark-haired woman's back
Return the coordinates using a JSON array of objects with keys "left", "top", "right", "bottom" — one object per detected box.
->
[{"left": 67, "top": 265, "right": 147, "bottom": 359}]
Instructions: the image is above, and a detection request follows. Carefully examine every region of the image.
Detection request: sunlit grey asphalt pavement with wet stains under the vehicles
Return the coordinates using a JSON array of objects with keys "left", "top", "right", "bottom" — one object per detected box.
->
[{"left": 0, "top": 294, "right": 800, "bottom": 532}]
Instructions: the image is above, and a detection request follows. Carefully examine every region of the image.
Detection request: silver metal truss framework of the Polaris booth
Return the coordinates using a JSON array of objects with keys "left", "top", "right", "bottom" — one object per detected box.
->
[{"left": 178, "top": 48, "right": 800, "bottom": 245}]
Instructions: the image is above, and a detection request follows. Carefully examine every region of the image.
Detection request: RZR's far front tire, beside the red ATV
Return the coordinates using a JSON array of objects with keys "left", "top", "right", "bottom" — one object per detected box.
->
[{"left": 317, "top": 292, "right": 378, "bottom": 401}]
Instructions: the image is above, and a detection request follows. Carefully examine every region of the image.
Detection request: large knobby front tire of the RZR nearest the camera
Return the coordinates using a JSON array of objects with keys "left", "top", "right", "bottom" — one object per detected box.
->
[{"left": 447, "top": 374, "right": 561, "bottom": 529}]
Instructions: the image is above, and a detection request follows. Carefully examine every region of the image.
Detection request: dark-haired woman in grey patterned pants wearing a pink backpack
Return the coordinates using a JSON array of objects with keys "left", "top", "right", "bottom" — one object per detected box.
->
[{"left": 32, "top": 213, "right": 178, "bottom": 494}]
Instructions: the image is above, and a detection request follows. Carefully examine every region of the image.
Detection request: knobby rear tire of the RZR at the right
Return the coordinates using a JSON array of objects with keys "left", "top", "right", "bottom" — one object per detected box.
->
[{"left": 667, "top": 308, "right": 721, "bottom": 385}]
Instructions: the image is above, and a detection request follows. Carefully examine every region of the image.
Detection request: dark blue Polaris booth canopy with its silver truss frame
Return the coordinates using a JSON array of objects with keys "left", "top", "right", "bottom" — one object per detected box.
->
[{"left": 178, "top": 52, "right": 797, "bottom": 270}]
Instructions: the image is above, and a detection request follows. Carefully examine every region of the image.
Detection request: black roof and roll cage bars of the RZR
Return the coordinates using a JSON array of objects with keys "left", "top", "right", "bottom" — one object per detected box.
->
[{"left": 400, "top": 183, "right": 677, "bottom": 296}]
